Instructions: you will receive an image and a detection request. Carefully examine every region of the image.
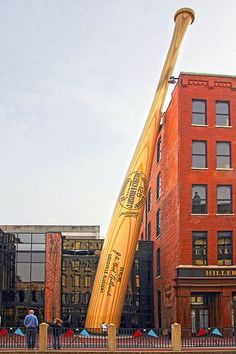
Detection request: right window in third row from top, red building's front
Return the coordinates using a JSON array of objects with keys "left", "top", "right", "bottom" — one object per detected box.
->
[{"left": 217, "top": 186, "right": 232, "bottom": 214}]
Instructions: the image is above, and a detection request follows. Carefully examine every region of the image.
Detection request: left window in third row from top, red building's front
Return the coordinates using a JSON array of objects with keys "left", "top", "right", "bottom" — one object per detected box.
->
[{"left": 192, "top": 184, "right": 207, "bottom": 214}]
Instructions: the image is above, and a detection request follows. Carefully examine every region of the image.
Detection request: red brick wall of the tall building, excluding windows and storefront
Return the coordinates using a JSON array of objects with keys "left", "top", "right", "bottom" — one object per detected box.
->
[{"left": 140, "top": 73, "right": 236, "bottom": 327}]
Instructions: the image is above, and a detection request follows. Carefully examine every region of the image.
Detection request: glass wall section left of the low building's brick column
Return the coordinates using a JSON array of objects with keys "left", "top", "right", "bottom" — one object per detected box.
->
[{"left": 0, "top": 233, "right": 45, "bottom": 326}]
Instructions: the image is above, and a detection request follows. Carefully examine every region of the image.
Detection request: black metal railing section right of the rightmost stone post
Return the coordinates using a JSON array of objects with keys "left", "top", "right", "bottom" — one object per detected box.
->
[{"left": 182, "top": 327, "right": 236, "bottom": 347}]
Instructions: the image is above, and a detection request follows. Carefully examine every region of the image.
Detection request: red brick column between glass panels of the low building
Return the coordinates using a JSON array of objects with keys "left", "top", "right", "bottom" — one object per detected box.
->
[{"left": 45, "top": 233, "right": 62, "bottom": 322}]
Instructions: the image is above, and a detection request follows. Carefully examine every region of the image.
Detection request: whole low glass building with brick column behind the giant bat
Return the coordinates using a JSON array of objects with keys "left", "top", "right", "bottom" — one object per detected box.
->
[{"left": 0, "top": 225, "right": 153, "bottom": 328}]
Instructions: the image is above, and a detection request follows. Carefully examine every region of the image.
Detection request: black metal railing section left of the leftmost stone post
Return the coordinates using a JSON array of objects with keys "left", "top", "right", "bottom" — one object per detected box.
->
[{"left": 0, "top": 327, "right": 38, "bottom": 349}]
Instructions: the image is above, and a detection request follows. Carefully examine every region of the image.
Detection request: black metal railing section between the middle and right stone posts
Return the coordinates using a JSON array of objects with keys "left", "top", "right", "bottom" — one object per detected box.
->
[{"left": 116, "top": 328, "right": 171, "bottom": 349}]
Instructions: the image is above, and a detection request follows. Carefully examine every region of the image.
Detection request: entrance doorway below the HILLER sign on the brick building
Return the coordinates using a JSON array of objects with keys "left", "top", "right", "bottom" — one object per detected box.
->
[{"left": 191, "top": 293, "right": 219, "bottom": 333}]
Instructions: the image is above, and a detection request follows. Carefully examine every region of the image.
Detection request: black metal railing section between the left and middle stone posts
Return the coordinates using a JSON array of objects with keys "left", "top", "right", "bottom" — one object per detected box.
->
[{"left": 48, "top": 327, "right": 108, "bottom": 349}]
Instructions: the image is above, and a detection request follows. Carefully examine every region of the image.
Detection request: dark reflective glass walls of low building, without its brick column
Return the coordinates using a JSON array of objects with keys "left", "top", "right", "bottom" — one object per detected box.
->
[{"left": 0, "top": 232, "right": 153, "bottom": 328}]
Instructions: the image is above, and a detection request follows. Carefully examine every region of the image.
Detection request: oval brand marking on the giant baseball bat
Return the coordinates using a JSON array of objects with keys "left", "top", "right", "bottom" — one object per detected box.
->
[{"left": 119, "top": 171, "right": 147, "bottom": 210}]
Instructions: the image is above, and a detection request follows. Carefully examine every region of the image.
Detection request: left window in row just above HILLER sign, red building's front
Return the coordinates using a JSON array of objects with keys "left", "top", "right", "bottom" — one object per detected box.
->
[{"left": 192, "top": 231, "right": 207, "bottom": 265}]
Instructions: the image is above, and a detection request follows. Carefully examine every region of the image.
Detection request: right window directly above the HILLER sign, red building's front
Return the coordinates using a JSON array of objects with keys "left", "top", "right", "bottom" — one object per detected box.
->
[{"left": 217, "top": 231, "right": 233, "bottom": 265}]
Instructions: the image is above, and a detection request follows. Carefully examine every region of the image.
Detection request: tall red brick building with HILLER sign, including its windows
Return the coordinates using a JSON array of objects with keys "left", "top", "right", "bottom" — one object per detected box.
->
[{"left": 140, "top": 73, "right": 236, "bottom": 331}]
